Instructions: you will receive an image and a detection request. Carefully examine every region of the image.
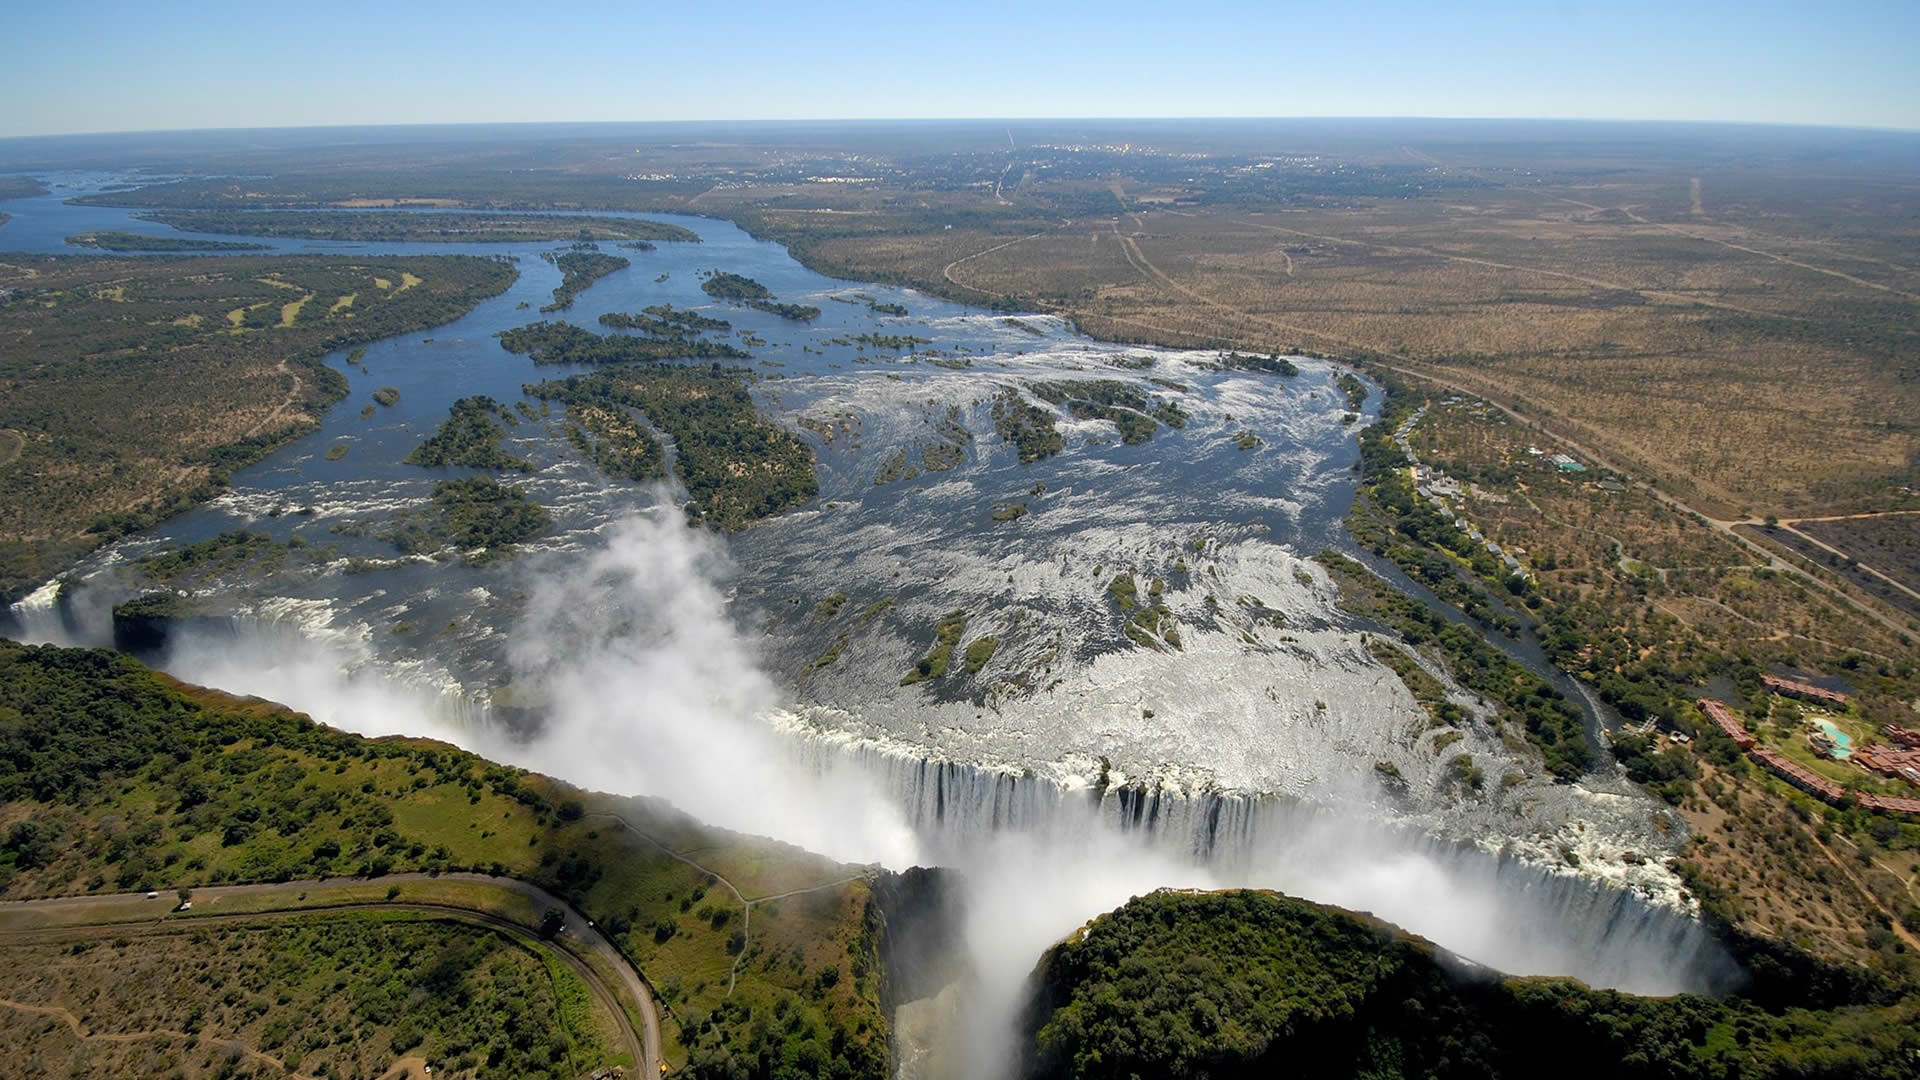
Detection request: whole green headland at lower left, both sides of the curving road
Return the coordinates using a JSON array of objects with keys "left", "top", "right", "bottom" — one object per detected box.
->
[{"left": 0, "top": 640, "right": 889, "bottom": 1080}]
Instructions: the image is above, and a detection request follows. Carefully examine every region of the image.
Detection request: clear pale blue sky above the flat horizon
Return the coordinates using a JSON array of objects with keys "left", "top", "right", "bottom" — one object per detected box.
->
[{"left": 0, "top": 0, "right": 1920, "bottom": 136}]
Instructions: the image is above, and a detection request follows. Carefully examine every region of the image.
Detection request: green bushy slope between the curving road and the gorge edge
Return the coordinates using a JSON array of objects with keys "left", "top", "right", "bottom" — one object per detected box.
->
[{"left": 0, "top": 642, "right": 887, "bottom": 1080}]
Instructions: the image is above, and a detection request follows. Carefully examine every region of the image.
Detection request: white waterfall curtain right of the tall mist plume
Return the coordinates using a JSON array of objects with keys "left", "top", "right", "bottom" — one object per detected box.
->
[{"left": 789, "top": 730, "right": 1741, "bottom": 994}]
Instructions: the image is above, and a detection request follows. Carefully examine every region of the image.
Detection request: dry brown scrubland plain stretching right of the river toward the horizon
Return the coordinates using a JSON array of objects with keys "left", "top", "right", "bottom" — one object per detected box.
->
[{"left": 714, "top": 177, "right": 1920, "bottom": 517}]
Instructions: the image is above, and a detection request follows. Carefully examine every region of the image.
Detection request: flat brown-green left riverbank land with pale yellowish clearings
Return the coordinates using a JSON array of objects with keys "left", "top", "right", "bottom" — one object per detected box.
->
[{"left": 0, "top": 256, "right": 516, "bottom": 601}]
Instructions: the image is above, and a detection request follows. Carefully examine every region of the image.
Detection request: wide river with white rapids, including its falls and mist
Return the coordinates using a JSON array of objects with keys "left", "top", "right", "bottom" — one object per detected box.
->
[{"left": 0, "top": 175, "right": 1730, "bottom": 992}]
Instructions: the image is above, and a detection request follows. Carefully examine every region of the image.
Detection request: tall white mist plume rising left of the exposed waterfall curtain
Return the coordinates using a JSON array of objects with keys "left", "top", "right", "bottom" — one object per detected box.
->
[{"left": 509, "top": 498, "right": 918, "bottom": 869}]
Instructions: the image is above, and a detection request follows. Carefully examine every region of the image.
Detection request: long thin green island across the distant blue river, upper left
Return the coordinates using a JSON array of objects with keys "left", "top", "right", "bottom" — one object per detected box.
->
[{"left": 140, "top": 209, "right": 699, "bottom": 250}]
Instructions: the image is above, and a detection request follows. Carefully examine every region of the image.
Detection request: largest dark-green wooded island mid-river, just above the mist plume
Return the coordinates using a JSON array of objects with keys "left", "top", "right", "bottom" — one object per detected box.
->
[{"left": 526, "top": 363, "right": 820, "bottom": 528}]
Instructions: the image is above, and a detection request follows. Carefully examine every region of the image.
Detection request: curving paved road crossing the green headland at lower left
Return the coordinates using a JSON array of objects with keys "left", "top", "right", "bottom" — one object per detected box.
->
[{"left": 0, "top": 874, "right": 664, "bottom": 1076}]
